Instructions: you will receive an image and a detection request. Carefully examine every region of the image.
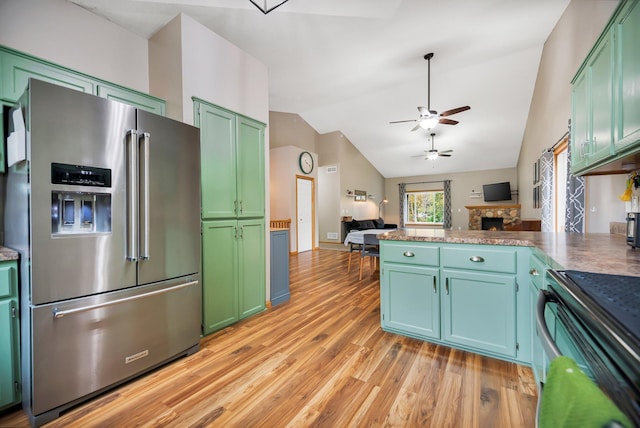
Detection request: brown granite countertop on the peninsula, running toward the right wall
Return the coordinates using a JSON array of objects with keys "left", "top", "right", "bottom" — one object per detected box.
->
[{"left": 378, "top": 229, "right": 640, "bottom": 276}]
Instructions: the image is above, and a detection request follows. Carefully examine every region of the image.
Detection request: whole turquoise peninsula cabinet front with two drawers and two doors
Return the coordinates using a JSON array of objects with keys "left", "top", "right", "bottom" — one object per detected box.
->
[{"left": 380, "top": 240, "right": 531, "bottom": 364}]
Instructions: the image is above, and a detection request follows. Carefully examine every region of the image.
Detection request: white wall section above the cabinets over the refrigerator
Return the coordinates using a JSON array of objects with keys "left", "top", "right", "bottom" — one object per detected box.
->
[{"left": 0, "top": 0, "right": 149, "bottom": 92}]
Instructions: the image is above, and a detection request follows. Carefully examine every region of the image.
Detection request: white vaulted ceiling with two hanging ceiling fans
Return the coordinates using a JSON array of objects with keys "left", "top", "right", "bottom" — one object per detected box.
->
[{"left": 71, "top": 0, "right": 570, "bottom": 178}]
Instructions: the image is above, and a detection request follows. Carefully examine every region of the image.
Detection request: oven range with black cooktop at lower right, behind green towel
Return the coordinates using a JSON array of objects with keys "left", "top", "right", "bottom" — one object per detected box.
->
[{"left": 536, "top": 270, "right": 640, "bottom": 427}]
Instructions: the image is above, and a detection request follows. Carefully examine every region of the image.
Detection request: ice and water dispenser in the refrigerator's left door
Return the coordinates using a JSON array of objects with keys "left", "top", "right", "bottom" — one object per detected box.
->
[{"left": 51, "top": 163, "right": 111, "bottom": 235}]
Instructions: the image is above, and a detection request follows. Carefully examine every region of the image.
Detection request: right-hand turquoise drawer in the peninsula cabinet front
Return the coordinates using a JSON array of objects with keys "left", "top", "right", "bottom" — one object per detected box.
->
[{"left": 442, "top": 246, "right": 516, "bottom": 273}]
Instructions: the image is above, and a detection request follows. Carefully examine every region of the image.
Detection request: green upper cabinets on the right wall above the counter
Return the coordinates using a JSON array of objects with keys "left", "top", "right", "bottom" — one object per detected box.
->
[{"left": 571, "top": 0, "right": 640, "bottom": 175}]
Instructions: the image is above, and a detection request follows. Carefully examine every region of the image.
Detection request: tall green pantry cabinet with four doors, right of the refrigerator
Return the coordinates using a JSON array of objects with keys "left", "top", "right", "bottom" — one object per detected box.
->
[{"left": 194, "top": 98, "right": 266, "bottom": 335}]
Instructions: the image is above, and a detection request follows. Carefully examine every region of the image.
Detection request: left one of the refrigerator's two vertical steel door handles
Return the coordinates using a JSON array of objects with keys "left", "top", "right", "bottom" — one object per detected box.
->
[{"left": 125, "top": 130, "right": 138, "bottom": 262}]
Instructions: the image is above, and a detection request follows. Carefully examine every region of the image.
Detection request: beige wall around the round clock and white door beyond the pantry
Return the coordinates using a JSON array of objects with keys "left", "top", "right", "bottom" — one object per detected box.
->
[{"left": 269, "top": 111, "right": 384, "bottom": 246}]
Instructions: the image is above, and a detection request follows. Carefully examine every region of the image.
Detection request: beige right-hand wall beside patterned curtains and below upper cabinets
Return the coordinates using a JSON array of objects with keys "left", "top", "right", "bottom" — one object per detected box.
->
[{"left": 517, "top": 0, "right": 626, "bottom": 232}]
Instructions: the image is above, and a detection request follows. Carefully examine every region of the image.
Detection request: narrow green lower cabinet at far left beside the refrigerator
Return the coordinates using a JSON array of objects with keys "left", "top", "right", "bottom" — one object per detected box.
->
[{"left": 0, "top": 261, "right": 21, "bottom": 410}]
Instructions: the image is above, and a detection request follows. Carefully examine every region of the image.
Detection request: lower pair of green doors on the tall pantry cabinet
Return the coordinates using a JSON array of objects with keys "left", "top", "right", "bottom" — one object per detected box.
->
[{"left": 202, "top": 219, "right": 266, "bottom": 335}]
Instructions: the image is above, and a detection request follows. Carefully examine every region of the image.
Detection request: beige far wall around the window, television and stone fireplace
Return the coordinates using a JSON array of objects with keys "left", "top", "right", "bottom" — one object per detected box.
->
[{"left": 384, "top": 168, "right": 519, "bottom": 230}]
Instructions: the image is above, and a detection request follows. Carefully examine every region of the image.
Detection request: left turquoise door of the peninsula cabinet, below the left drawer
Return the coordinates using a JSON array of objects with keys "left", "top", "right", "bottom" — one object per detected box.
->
[{"left": 380, "top": 263, "right": 440, "bottom": 339}]
